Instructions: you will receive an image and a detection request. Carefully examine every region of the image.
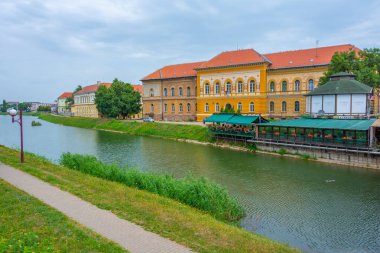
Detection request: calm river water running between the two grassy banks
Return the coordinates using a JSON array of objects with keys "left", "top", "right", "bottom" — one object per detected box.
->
[{"left": 0, "top": 116, "right": 380, "bottom": 252}]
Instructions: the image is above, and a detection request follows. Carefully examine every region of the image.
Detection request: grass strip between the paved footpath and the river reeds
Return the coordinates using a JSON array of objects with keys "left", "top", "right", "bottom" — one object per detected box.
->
[{"left": 0, "top": 146, "right": 297, "bottom": 252}]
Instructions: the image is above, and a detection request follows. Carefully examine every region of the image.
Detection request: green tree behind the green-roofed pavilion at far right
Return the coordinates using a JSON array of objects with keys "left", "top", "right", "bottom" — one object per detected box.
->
[{"left": 319, "top": 48, "right": 380, "bottom": 87}]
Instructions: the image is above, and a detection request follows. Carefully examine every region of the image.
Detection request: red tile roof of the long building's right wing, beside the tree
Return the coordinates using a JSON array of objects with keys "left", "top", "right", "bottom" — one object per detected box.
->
[{"left": 265, "top": 44, "right": 360, "bottom": 69}]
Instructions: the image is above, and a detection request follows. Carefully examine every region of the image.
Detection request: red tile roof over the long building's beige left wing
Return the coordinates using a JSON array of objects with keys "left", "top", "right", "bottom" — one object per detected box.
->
[{"left": 142, "top": 62, "right": 203, "bottom": 81}]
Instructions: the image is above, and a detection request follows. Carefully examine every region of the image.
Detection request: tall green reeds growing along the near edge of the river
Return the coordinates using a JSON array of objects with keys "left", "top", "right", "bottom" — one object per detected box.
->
[{"left": 60, "top": 153, "right": 244, "bottom": 221}]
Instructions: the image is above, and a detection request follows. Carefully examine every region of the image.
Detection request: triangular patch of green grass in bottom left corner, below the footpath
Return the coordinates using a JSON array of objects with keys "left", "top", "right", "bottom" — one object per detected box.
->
[{"left": 0, "top": 180, "right": 126, "bottom": 252}]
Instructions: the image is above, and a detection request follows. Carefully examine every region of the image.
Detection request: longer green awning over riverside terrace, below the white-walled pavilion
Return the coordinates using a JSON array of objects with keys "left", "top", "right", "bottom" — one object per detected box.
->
[{"left": 258, "top": 119, "right": 376, "bottom": 131}]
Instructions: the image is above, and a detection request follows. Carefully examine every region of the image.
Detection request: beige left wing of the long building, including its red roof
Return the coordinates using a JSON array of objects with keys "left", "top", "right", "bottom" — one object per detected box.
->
[{"left": 141, "top": 62, "right": 202, "bottom": 121}]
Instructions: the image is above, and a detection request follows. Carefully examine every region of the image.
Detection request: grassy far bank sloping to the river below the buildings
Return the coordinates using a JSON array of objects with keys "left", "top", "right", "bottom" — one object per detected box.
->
[{"left": 39, "top": 114, "right": 212, "bottom": 142}]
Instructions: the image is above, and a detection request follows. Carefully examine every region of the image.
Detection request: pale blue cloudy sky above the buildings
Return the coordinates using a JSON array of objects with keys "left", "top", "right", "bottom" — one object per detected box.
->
[{"left": 0, "top": 0, "right": 380, "bottom": 102}]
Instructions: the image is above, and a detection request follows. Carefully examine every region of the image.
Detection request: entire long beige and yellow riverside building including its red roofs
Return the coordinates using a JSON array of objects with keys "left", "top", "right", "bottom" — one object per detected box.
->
[{"left": 142, "top": 44, "right": 366, "bottom": 121}]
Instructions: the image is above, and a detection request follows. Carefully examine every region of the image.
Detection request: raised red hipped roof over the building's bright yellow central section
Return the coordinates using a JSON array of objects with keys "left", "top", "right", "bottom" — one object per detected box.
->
[{"left": 200, "top": 49, "right": 268, "bottom": 69}]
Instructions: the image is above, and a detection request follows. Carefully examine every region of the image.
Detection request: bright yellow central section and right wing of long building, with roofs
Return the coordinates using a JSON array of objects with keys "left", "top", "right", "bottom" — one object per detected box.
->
[{"left": 196, "top": 45, "right": 359, "bottom": 121}]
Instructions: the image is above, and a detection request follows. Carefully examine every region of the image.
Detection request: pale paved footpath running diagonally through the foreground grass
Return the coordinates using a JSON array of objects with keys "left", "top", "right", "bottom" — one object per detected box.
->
[{"left": 0, "top": 163, "right": 191, "bottom": 253}]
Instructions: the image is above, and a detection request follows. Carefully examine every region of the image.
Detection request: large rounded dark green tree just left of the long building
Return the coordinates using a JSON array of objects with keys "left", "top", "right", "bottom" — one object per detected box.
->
[{"left": 95, "top": 79, "right": 141, "bottom": 118}]
